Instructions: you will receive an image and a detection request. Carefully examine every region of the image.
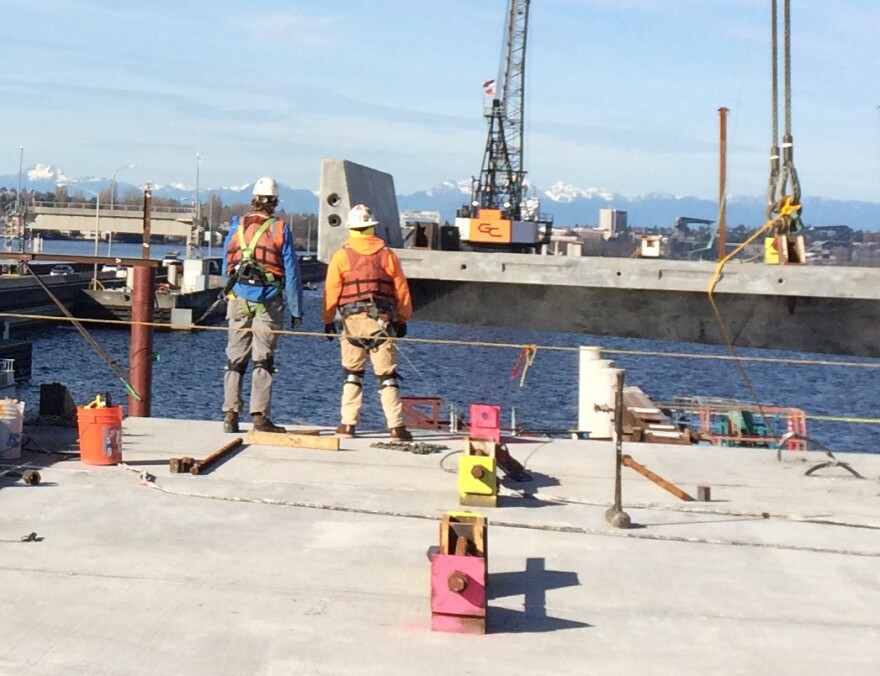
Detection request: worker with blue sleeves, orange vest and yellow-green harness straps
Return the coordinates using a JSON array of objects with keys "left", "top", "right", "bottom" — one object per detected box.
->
[{"left": 223, "top": 177, "right": 303, "bottom": 433}]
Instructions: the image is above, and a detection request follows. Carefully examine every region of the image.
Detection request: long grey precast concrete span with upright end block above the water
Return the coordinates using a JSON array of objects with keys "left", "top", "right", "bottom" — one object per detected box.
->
[{"left": 318, "top": 160, "right": 880, "bottom": 358}]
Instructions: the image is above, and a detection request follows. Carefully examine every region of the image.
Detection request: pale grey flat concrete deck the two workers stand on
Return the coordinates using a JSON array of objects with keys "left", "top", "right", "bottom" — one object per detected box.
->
[{"left": 0, "top": 418, "right": 880, "bottom": 676}]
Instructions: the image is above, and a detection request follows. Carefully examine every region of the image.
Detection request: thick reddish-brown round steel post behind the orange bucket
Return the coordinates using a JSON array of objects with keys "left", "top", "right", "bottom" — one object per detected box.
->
[{"left": 128, "top": 265, "right": 156, "bottom": 418}]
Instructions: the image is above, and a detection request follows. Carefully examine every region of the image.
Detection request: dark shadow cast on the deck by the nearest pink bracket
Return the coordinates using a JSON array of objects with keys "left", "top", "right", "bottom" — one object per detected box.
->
[{"left": 487, "top": 557, "right": 592, "bottom": 634}]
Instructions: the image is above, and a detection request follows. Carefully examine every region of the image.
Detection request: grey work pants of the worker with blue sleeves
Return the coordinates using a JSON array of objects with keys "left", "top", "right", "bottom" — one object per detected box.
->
[{"left": 223, "top": 293, "right": 284, "bottom": 417}]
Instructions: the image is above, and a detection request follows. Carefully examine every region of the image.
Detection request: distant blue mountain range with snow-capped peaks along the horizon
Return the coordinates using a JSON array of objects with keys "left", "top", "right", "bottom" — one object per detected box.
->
[{"left": 0, "top": 164, "right": 880, "bottom": 230}]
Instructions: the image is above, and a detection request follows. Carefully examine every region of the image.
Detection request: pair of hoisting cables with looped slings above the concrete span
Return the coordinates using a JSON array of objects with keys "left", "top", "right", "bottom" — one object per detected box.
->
[{"left": 767, "top": 0, "right": 802, "bottom": 238}]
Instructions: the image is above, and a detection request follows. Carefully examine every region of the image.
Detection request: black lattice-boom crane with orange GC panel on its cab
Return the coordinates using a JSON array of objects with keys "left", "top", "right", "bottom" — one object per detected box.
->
[{"left": 455, "top": 0, "right": 552, "bottom": 253}]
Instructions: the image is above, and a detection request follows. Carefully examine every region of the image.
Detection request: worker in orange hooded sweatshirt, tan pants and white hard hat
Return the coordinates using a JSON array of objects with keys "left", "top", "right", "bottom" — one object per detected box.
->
[{"left": 321, "top": 204, "right": 412, "bottom": 441}]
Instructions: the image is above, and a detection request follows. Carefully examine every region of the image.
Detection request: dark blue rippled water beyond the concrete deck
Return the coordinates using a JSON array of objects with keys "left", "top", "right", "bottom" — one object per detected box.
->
[{"left": 12, "top": 240, "right": 880, "bottom": 452}]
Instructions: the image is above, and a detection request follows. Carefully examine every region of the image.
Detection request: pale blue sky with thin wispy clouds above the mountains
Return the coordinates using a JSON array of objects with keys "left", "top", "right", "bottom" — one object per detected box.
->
[{"left": 0, "top": 0, "right": 880, "bottom": 202}]
